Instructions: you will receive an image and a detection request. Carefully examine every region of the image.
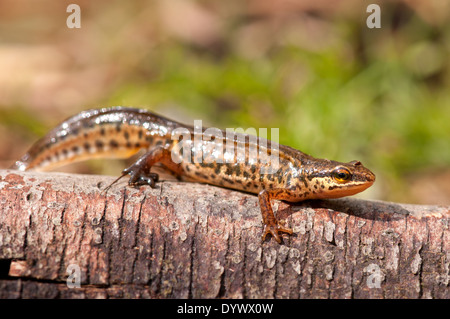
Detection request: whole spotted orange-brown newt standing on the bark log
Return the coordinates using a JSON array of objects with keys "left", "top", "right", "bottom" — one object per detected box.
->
[{"left": 11, "top": 106, "right": 375, "bottom": 243}]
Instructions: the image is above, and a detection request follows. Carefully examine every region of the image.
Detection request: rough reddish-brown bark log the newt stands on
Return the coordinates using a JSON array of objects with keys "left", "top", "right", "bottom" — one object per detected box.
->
[{"left": 0, "top": 170, "right": 450, "bottom": 298}]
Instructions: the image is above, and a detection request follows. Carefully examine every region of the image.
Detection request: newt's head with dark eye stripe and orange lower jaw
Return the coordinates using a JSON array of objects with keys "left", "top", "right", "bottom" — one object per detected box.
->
[{"left": 304, "top": 160, "right": 375, "bottom": 199}]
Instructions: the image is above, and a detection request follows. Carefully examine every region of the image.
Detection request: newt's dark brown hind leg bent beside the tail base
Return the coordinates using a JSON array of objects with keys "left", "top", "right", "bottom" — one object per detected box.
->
[{"left": 105, "top": 146, "right": 182, "bottom": 190}]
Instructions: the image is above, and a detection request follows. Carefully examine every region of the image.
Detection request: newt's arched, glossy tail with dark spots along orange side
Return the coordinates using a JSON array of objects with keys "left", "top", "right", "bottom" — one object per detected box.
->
[{"left": 11, "top": 107, "right": 180, "bottom": 171}]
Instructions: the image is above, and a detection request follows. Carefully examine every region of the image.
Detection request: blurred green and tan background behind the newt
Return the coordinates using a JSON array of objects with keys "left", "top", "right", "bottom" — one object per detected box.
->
[{"left": 0, "top": 0, "right": 450, "bottom": 204}]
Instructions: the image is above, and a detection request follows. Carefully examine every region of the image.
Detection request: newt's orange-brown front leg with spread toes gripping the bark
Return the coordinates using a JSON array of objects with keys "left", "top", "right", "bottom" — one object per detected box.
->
[{"left": 258, "top": 190, "right": 292, "bottom": 243}]
